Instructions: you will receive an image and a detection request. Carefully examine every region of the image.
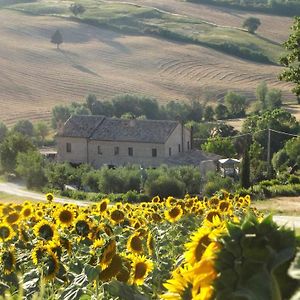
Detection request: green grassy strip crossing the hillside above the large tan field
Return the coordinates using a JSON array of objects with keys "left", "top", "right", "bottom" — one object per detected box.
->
[{"left": 10, "top": 0, "right": 282, "bottom": 63}]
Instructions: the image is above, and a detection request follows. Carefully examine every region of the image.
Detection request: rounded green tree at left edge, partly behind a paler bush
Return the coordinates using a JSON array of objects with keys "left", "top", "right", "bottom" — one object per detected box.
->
[{"left": 0, "top": 132, "right": 34, "bottom": 173}]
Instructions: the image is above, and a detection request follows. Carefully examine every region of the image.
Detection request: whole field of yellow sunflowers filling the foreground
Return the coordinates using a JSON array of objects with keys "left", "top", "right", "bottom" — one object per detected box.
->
[{"left": 0, "top": 191, "right": 300, "bottom": 300}]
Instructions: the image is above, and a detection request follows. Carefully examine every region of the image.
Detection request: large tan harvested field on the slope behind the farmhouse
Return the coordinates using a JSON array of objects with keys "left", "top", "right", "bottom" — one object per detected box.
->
[{"left": 0, "top": 6, "right": 292, "bottom": 125}]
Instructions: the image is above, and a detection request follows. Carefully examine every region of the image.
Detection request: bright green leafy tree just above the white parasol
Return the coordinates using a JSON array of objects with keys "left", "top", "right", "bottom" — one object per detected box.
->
[{"left": 201, "top": 136, "right": 236, "bottom": 157}]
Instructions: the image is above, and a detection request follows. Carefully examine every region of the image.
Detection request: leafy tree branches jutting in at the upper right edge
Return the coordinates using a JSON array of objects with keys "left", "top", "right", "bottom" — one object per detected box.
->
[{"left": 279, "top": 17, "right": 300, "bottom": 104}]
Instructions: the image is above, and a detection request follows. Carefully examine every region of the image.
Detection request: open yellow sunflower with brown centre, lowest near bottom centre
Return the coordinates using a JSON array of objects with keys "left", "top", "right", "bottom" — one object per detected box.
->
[{"left": 130, "top": 255, "right": 153, "bottom": 285}]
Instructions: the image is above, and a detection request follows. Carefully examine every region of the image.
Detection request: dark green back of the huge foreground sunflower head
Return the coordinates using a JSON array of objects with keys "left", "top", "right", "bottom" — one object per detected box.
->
[{"left": 215, "top": 215, "right": 297, "bottom": 300}]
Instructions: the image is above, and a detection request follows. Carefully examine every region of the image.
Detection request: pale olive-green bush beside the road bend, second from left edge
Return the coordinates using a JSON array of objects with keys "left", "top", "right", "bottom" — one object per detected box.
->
[{"left": 16, "top": 150, "right": 46, "bottom": 188}]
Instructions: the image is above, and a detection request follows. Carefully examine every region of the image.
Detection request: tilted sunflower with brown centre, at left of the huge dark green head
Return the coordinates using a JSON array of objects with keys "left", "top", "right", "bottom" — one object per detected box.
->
[{"left": 184, "top": 227, "right": 214, "bottom": 265}]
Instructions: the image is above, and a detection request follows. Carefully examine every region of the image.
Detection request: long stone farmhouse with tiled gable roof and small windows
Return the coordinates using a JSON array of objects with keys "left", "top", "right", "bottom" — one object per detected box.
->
[{"left": 56, "top": 116, "right": 192, "bottom": 168}]
